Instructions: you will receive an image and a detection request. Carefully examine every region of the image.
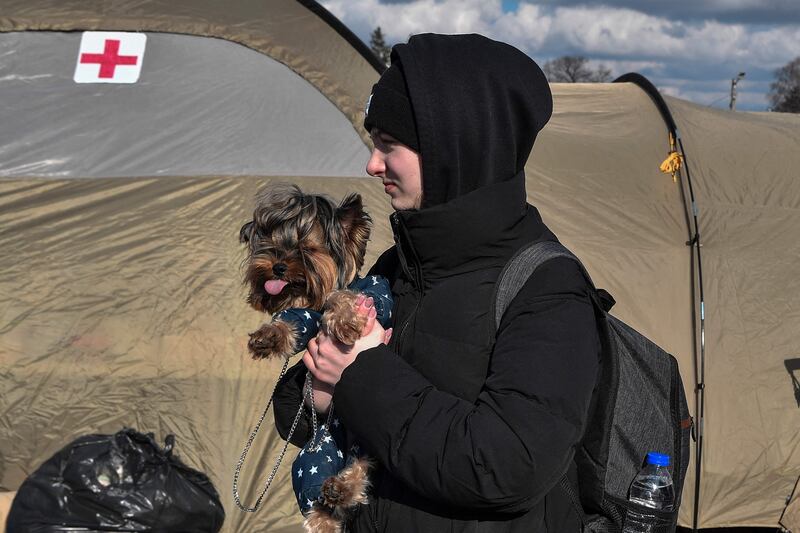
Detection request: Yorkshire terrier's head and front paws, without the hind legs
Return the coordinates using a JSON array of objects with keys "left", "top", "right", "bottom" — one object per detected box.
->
[{"left": 239, "top": 184, "right": 372, "bottom": 359}]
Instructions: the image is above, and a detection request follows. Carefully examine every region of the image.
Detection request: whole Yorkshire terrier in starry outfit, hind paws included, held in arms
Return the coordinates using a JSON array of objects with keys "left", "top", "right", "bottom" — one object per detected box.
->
[{"left": 239, "top": 184, "right": 391, "bottom": 533}]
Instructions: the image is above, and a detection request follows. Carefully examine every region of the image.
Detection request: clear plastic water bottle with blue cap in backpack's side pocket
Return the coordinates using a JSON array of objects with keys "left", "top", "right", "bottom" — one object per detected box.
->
[{"left": 622, "top": 452, "right": 675, "bottom": 533}]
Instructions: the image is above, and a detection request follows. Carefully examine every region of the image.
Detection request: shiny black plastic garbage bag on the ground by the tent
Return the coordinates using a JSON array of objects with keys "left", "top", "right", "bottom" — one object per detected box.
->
[{"left": 6, "top": 429, "right": 225, "bottom": 533}]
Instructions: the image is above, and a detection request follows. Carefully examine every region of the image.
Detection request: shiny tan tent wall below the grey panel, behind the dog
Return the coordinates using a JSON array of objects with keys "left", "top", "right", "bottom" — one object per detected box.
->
[{"left": 0, "top": 177, "right": 388, "bottom": 531}]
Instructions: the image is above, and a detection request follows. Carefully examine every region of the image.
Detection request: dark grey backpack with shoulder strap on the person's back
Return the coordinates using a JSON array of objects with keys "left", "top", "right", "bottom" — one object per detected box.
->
[{"left": 494, "top": 241, "right": 692, "bottom": 533}]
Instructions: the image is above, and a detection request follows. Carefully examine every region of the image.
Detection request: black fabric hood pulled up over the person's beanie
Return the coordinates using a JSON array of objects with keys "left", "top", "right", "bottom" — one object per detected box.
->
[{"left": 392, "top": 34, "right": 553, "bottom": 208}]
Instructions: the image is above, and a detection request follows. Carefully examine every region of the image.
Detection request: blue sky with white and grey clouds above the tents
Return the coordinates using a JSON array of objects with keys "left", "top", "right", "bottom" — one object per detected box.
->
[{"left": 320, "top": 0, "right": 800, "bottom": 111}]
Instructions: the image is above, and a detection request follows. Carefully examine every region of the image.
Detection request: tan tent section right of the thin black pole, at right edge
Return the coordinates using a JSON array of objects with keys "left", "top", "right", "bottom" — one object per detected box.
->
[{"left": 670, "top": 96, "right": 800, "bottom": 526}]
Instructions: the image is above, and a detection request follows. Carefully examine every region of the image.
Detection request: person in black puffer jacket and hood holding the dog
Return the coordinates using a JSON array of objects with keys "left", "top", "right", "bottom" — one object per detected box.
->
[{"left": 275, "top": 34, "right": 600, "bottom": 533}]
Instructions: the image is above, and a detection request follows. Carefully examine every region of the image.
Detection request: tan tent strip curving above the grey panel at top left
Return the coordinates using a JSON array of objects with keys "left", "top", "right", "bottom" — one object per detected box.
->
[{"left": 0, "top": 0, "right": 377, "bottom": 142}]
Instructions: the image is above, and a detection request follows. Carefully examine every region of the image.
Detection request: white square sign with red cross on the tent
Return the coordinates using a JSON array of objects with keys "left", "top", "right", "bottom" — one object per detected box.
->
[{"left": 73, "top": 31, "right": 147, "bottom": 83}]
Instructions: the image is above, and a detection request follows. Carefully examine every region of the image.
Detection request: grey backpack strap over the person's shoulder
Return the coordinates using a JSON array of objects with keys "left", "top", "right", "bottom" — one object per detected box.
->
[{"left": 493, "top": 241, "right": 600, "bottom": 331}]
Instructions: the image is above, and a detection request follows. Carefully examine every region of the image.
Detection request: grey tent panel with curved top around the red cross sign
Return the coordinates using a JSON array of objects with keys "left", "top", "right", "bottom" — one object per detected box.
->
[{"left": 0, "top": 32, "right": 368, "bottom": 177}]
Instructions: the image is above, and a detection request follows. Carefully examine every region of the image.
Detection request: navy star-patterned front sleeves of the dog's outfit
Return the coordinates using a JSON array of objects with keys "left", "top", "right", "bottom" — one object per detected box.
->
[{"left": 272, "top": 276, "right": 392, "bottom": 353}]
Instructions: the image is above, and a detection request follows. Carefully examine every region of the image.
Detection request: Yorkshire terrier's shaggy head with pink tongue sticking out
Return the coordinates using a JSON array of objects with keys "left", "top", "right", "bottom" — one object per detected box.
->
[{"left": 239, "top": 185, "right": 371, "bottom": 313}]
